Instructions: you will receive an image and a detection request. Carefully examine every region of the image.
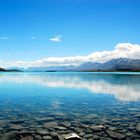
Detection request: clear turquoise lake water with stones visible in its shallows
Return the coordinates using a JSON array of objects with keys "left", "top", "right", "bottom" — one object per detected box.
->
[{"left": 0, "top": 72, "right": 140, "bottom": 140}]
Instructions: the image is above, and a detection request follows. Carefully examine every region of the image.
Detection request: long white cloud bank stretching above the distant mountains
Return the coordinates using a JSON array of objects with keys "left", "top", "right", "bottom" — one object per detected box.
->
[{"left": 0, "top": 43, "right": 140, "bottom": 68}]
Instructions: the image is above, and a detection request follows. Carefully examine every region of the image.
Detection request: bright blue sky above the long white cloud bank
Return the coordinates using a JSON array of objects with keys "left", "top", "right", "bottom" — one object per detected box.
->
[{"left": 0, "top": 0, "right": 140, "bottom": 64}]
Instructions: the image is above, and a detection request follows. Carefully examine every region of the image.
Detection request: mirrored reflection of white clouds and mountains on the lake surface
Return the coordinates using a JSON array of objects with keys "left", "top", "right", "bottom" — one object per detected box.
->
[{"left": 0, "top": 73, "right": 140, "bottom": 101}]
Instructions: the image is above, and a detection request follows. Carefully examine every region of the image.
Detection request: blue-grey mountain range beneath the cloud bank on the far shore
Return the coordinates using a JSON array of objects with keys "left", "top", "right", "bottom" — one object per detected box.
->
[{"left": 26, "top": 58, "right": 140, "bottom": 72}]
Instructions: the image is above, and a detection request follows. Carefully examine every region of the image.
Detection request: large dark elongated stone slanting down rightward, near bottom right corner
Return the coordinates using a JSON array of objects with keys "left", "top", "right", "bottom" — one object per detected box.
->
[{"left": 106, "top": 129, "right": 126, "bottom": 140}]
